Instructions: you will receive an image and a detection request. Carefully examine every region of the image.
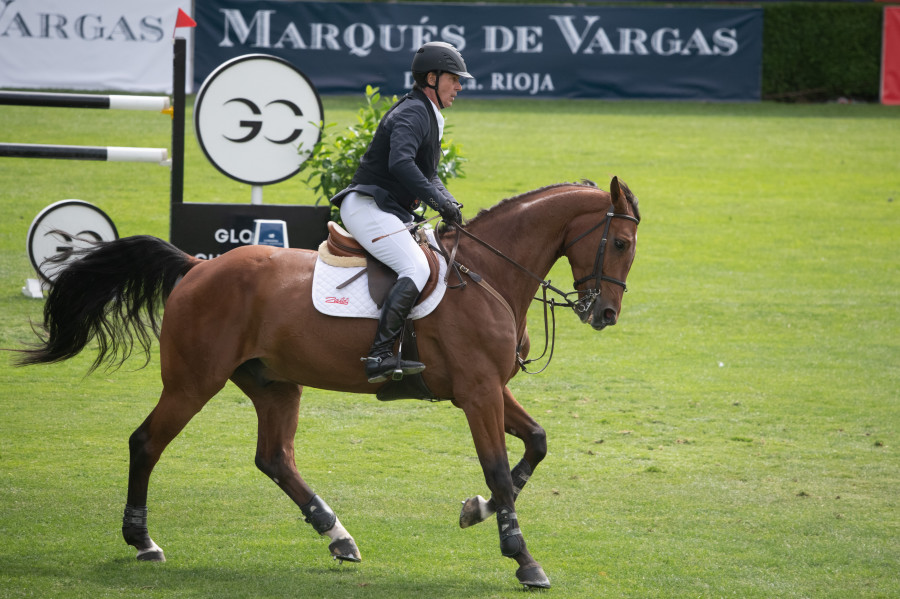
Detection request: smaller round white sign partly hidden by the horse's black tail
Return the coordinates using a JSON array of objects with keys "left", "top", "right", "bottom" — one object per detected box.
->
[{"left": 27, "top": 200, "right": 119, "bottom": 283}]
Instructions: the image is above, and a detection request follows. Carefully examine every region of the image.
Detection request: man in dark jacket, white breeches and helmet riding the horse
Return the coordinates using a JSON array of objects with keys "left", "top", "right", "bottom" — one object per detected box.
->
[{"left": 331, "top": 42, "right": 472, "bottom": 383}]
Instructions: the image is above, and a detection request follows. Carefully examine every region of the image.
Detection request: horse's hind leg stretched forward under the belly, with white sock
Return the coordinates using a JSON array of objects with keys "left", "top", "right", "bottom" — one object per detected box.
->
[{"left": 231, "top": 361, "right": 361, "bottom": 562}]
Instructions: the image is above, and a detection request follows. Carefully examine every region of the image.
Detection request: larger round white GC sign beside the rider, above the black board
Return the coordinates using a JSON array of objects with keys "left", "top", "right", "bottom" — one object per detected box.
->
[{"left": 194, "top": 54, "right": 324, "bottom": 185}]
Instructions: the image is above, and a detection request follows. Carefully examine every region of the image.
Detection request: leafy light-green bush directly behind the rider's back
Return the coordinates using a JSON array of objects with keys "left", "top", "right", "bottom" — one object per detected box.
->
[{"left": 299, "top": 85, "right": 466, "bottom": 222}]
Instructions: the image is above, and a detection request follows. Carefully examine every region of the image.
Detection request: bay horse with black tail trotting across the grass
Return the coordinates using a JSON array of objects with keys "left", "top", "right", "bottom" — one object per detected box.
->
[{"left": 19, "top": 177, "right": 640, "bottom": 588}]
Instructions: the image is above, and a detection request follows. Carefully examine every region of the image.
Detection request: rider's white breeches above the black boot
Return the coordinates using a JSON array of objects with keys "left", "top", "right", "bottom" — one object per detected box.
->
[{"left": 341, "top": 192, "right": 429, "bottom": 291}]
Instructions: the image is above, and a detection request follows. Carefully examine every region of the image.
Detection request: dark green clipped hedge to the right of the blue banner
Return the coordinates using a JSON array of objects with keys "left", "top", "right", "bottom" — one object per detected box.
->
[{"left": 762, "top": 2, "right": 883, "bottom": 101}]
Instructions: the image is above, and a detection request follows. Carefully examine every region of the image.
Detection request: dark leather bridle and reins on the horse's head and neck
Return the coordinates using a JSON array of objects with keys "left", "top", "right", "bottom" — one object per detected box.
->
[{"left": 435, "top": 206, "right": 640, "bottom": 374}]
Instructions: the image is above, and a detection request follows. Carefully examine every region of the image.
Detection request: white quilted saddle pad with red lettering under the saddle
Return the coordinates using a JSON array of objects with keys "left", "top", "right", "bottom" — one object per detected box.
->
[{"left": 312, "top": 230, "right": 447, "bottom": 320}]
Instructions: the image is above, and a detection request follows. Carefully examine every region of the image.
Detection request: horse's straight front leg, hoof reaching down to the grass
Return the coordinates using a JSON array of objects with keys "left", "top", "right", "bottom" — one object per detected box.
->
[{"left": 456, "top": 392, "right": 550, "bottom": 588}]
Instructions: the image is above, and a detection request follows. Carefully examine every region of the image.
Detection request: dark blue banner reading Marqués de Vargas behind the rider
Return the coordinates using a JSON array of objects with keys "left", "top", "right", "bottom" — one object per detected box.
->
[{"left": 194, "top": 0, "right": 763, "bottom": 101}]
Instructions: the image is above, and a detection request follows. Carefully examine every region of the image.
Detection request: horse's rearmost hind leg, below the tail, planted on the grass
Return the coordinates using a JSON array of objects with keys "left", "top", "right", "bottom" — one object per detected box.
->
[{"left": 122, "top": 389, "right": 215, "bottom": 562}]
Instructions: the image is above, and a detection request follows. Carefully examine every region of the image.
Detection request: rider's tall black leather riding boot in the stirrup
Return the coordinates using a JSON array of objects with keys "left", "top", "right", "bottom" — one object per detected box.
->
[{"left": 362, "top": 277, "right": 425, "bottom": 383}]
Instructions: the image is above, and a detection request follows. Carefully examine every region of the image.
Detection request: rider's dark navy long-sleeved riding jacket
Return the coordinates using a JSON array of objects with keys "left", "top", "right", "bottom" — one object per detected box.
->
[{"left": 331, "top": 89, "right": 455, "bottom": 222}]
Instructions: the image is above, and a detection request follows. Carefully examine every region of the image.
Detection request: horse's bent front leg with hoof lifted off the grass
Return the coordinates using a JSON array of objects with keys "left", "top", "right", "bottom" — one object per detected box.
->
[{"left": 459, "top": 387, "right": 547, "bottom": 528}]
